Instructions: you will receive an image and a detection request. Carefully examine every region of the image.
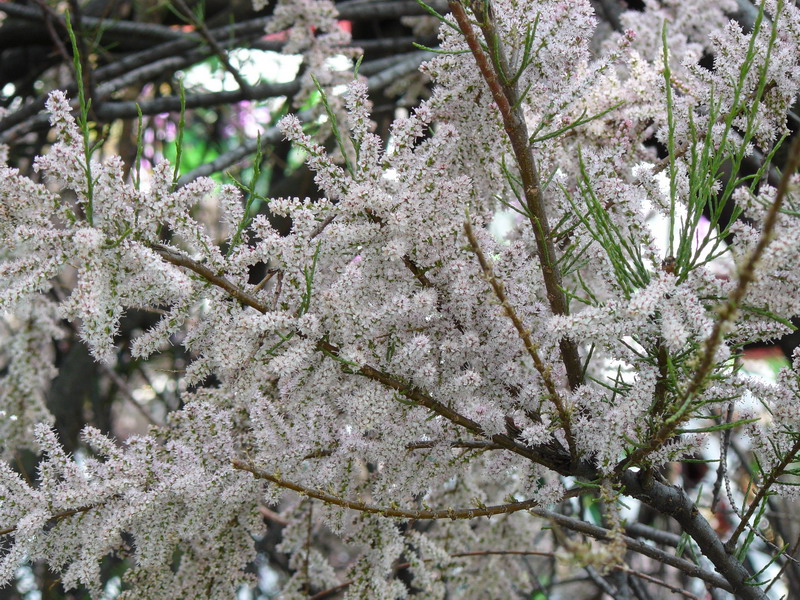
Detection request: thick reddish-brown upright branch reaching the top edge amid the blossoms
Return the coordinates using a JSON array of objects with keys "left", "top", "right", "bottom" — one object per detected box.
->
[{"left": 449, "top": 0, "right": 583, "bottom": 389}]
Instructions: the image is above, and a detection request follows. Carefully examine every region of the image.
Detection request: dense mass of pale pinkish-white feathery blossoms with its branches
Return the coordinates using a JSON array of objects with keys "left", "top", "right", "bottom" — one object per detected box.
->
[{"left": 0, "top": 0, "right": 800, "bottom": 599}]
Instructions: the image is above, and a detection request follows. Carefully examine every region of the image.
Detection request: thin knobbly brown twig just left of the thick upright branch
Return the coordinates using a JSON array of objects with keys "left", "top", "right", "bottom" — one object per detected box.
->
[{"left": 464, "top": 220, "right": 578, "bottom": 462}]
